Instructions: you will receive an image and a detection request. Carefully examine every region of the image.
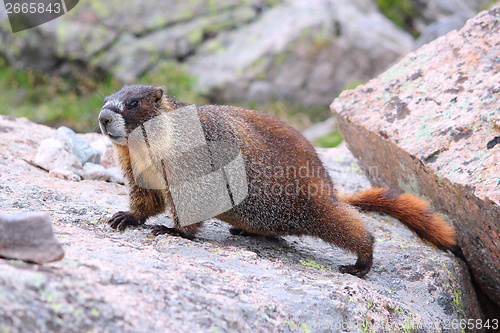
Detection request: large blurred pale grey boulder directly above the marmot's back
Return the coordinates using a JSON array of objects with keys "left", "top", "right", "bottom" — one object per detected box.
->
[{"left": 188, "top": 0, "right": 413, "bottom": 105}]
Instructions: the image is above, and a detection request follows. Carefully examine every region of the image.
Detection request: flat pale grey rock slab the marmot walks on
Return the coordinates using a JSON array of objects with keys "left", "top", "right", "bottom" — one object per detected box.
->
[{"left": 0, "top": 116, "right": 481, "bottom": 332}]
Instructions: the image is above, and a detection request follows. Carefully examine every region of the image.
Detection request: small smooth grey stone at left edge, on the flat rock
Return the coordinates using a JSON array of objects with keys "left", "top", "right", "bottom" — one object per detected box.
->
[{"left": 0, "top": 213, "right": 64, "bottom": 264}]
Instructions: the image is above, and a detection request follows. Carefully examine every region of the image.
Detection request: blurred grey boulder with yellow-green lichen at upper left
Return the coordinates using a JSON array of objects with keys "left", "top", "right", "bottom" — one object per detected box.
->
[{"left": 0, "top": 0, "right": 272, "bottom": 84}]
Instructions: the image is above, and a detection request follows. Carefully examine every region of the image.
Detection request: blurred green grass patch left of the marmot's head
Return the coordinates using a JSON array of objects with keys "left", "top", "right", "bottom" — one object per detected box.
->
[{"left": 0, "top": 58, "right": 121, "bottom": 132}]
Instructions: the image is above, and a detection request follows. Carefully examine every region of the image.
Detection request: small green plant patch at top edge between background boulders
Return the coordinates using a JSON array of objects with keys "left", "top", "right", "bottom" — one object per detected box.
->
[{"left": 377, "top": 0, "right": 418, "bottom": 37}]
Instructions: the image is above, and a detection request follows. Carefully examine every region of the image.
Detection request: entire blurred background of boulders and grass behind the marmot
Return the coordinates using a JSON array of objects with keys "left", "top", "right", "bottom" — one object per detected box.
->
[{"left": 0, "top": 0, "right": 492, "bottom": 135}]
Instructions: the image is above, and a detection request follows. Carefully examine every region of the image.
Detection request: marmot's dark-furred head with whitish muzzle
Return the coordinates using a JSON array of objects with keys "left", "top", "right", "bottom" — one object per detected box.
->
[{"left": 99, "top": 85, "right": 169, "bottom": 146}]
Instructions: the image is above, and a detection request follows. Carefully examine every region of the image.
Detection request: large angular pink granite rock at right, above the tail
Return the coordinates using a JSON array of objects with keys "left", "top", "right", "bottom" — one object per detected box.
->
[{"left": 331, "top": 7, "right": 500, "bottom": 304}]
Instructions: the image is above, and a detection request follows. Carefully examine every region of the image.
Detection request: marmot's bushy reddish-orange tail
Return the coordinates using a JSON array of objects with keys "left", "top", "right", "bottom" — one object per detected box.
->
[{"left": 339, "top": 187, "right": 456, "bottom": 250}]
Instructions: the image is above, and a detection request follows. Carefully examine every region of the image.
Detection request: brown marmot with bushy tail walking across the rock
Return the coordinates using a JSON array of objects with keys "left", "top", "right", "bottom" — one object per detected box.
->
[{"left": 99, "top": 85, "right": 456, "bottom": 277}]
